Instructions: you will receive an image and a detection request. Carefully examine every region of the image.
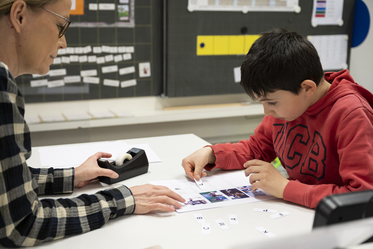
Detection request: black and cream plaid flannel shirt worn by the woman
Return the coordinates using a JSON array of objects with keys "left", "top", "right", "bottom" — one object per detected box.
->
[{"left": 0, "top": 62, "right": 135, "bottom": 247}]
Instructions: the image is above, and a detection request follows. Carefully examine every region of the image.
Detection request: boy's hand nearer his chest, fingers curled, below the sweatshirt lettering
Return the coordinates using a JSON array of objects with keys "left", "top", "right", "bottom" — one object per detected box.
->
[{"left": 244, "top": 159, "right": 289, "bottom": 198}]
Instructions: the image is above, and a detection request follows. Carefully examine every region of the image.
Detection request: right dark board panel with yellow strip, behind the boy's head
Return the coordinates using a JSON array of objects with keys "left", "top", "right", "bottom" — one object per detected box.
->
[{"left": 165, "top": 0, "right": 355, "bottom": 97}]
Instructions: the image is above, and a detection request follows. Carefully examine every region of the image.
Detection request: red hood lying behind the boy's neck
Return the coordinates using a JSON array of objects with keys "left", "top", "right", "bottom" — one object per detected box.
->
[{"left": 306, "top": 69, "right": 373, "bottom": 115}]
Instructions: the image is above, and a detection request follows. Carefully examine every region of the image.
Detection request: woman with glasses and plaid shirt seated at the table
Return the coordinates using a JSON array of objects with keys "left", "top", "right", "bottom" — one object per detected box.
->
[{"left": 0, "top": 0, "right": 185, "bottom": 247}]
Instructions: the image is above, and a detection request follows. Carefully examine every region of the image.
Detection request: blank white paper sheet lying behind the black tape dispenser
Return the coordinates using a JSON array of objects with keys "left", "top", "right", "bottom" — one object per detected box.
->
[{"left": 38, "top": 141, "right": 161, "bottom": 168}]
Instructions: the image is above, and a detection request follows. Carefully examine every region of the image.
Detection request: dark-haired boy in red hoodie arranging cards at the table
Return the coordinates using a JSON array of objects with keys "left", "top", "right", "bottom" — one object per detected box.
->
[{"left": 182, "top": 29, "right": 373, "bottom": 208}]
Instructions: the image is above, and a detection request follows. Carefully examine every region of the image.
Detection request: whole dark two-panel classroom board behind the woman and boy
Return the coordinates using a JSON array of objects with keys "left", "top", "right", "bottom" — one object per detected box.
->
[{"left": 16, "top": 0, "right": 355, "bottom": 103}]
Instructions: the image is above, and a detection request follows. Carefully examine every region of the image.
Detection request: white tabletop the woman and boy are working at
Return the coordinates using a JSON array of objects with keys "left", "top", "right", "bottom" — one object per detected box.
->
[{"left": 24, "top": 134, "right": 314, "bottom": 249}]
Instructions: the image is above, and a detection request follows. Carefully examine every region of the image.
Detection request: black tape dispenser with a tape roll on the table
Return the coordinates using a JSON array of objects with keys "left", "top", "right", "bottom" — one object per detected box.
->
[{"left": 97, "top": 148, "right": 149, "bottom": 184}]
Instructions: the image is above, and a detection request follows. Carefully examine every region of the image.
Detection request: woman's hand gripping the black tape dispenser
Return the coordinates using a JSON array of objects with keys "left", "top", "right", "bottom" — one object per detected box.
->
[{"left": 74, "top": 152, "right": 119, "bottom": 188}]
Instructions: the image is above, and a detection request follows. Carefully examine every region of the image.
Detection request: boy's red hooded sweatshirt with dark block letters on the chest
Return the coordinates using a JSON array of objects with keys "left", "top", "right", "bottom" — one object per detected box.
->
[{"left": 207, "top": 70, "right": 373, "bottom": 208}]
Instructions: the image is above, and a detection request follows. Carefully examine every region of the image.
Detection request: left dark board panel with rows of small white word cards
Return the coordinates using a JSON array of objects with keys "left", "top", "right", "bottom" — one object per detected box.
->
[{"left": 16, "top": 0, "right": 163, "bottom": 103}]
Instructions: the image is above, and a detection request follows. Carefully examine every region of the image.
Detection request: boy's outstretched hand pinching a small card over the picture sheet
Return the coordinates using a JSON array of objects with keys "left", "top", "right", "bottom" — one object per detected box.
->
[{"left": 181, "top": 147, "right": 216, "bottom": 181}]
